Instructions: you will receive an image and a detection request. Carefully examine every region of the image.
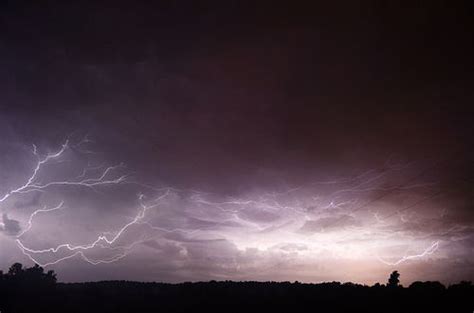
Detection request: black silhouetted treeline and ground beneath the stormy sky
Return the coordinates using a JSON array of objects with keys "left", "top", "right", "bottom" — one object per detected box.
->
[{"left": 0, "top": 267, "right": 474, "bottom": 313}]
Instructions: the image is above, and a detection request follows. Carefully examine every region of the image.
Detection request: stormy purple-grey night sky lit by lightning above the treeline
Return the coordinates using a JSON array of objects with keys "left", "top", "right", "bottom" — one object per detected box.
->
[{"left": 0, "top": 1, "right": 474, "bottom": 284}]
